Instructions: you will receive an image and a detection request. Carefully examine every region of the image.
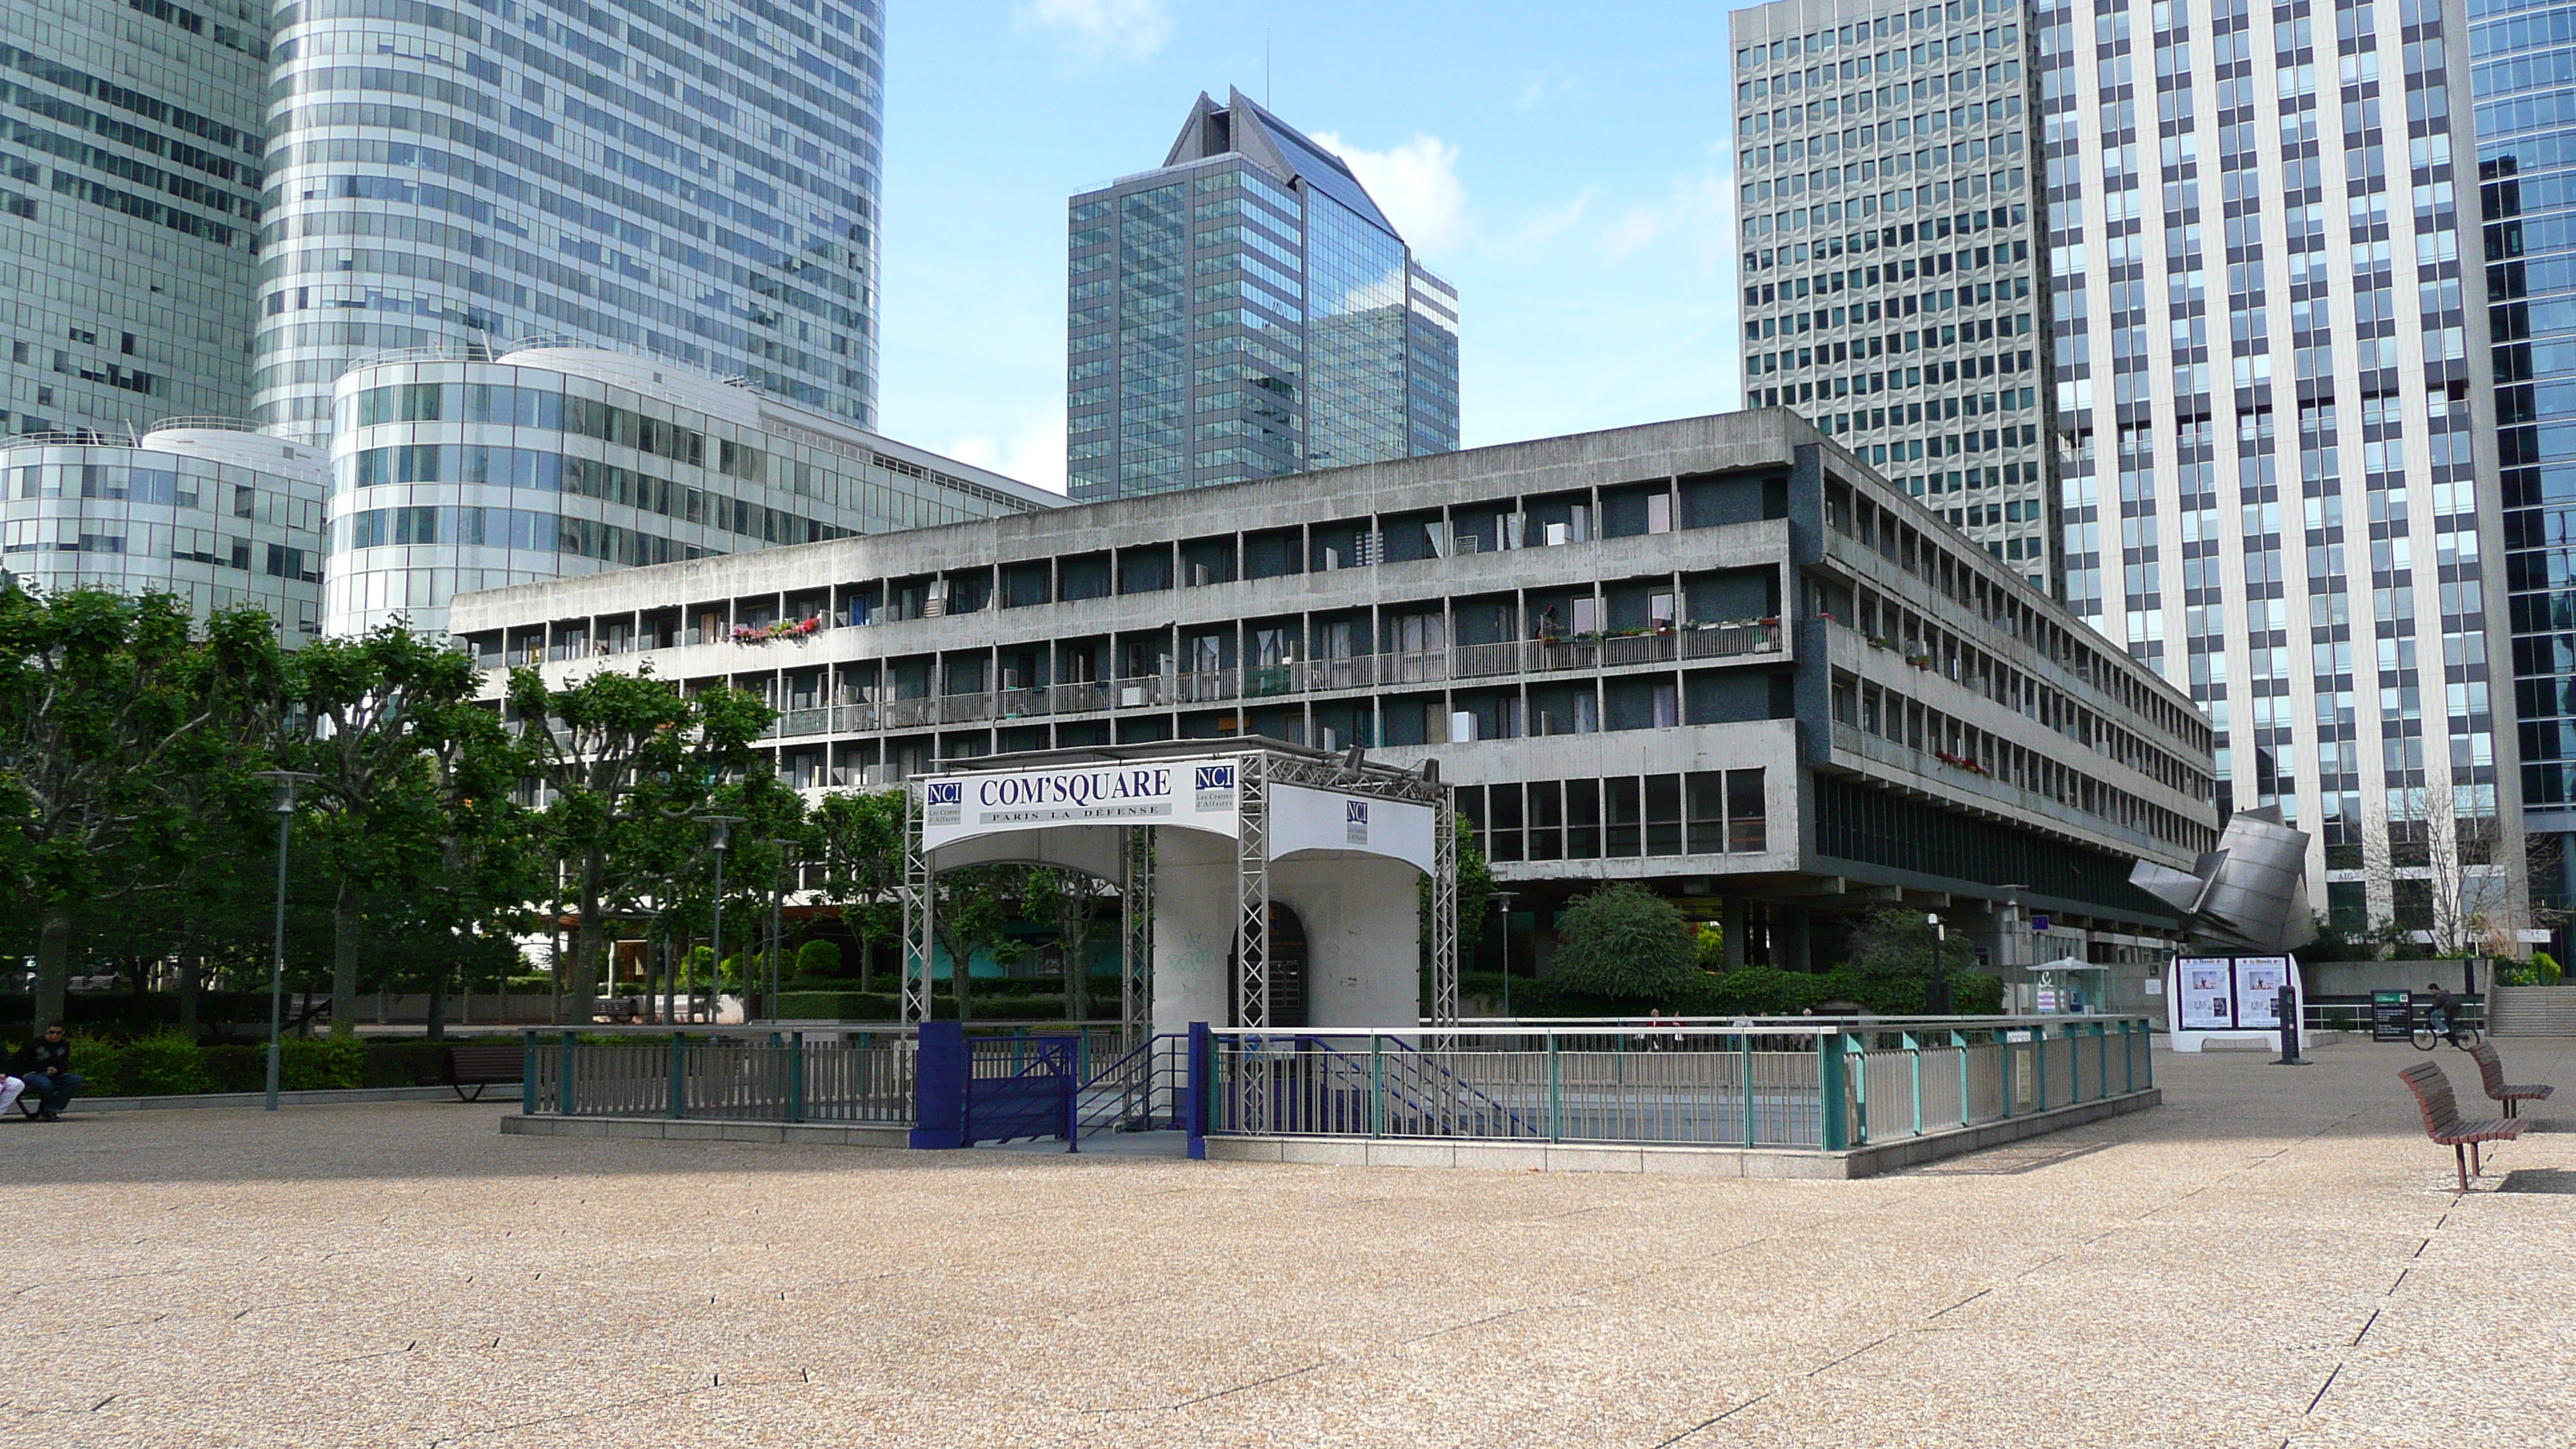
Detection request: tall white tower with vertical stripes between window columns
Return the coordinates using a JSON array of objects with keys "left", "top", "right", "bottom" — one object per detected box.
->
[{"left": 2035, "top": 0, "right": 2524, "bottom": 923}]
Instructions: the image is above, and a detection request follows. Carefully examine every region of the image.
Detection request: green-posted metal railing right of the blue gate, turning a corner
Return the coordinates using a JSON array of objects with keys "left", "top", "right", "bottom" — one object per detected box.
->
[{"left": 1208, "top": 1016, "right": 2153, "bottom": 1150}]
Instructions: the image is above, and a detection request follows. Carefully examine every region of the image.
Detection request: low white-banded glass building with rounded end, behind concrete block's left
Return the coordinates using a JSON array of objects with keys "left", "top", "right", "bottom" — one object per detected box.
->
[{"left": 322, "top": 348, "right": 1064, "bottom": 634}]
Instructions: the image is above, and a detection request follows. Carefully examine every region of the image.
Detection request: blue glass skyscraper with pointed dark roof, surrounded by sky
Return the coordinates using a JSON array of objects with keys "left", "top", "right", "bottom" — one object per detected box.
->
[{"left": 1067, "top": 91, "right": 1458, "bottom": 500}]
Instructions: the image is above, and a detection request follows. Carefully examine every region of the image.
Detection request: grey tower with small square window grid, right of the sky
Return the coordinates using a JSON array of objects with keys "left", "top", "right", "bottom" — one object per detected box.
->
[{"left": 1731, "top": 0, "right": 2058, "bottom": 591}]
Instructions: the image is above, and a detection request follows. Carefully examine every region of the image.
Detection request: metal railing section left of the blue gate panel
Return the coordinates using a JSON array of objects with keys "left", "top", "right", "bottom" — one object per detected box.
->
[{"left": 520, "top": 1029, "right": 917, "bottom": 1127}]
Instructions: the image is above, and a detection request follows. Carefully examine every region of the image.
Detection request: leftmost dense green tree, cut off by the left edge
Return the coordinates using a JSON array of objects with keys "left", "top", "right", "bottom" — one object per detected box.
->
[{"left": 0, "top": 585, "right": 278, "bottom": 1021}]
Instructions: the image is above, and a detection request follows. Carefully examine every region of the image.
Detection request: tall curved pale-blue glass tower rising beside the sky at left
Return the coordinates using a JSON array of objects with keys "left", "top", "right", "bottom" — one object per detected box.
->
[{"left": 252, "top": 0, "right": 884, "bottom": 441}]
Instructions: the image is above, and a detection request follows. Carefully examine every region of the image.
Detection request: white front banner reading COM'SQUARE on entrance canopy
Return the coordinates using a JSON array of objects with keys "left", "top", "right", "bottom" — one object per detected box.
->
[{"left": 922, "top": 755, "right": 1242, "bottom": 851}]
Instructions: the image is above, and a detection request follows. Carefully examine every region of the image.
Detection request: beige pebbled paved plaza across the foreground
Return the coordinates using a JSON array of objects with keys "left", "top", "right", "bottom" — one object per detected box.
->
[{"left": 0, "top": 1042, "right": 2576, "bottom": 1449}]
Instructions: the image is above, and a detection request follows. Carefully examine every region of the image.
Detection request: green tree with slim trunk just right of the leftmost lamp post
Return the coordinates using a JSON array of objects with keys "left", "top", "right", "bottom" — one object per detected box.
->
[{"left": 286, "top": 618, "right": 481, "bottom": 1036}]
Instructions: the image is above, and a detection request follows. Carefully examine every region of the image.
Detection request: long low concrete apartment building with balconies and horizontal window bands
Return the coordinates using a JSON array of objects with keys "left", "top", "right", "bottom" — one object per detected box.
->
[{"left": 450, "top": 399, "right": 2218, "bottom": 1005}]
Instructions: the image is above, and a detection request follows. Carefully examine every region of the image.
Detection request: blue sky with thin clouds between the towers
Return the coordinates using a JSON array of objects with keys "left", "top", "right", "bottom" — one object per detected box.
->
[{"left": 879, "top": 0, "right": 1738, "bottom": 488}]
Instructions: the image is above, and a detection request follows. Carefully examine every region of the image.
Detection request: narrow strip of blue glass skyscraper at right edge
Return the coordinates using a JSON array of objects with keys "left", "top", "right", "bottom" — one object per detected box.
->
[{"left": 2468, "top": 0, "right": 2576, "bottom": 917}]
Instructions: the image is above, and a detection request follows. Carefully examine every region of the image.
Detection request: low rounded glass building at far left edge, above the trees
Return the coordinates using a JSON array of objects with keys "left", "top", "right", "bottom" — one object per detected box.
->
[{"left": 0, "top": 428, "right": 324, "bottom": 645}]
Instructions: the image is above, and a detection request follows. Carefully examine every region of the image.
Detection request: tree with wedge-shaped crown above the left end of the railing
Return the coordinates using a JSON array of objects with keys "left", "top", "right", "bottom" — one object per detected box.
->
[{"left": 508, "top": 668, "right": 778, "bottom": 1016}]
